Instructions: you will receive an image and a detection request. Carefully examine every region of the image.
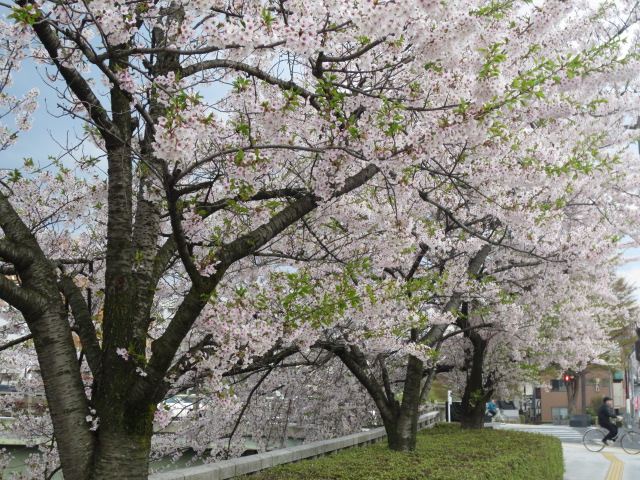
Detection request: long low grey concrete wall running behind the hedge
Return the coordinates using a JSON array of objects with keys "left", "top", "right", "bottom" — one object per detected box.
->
[{"left": 149, "top": 411, "right": 441, "bottom": 480}]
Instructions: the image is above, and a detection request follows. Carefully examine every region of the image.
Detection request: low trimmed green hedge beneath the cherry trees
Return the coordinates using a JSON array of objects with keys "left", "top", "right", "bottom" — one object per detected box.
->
[{"left": 245, "top": 424, "right": 564, "bottom": 480}]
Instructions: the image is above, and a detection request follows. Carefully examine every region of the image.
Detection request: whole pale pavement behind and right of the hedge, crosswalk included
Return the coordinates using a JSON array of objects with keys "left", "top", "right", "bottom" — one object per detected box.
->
[{"left": 494, "top": 425, "right": 640, "bottom": 480}]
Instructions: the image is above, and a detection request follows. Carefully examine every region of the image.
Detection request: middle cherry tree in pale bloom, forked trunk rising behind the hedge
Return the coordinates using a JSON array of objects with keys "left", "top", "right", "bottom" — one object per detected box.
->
[{"left": 229, "top": 0, "right": 636, "bottom": 450}]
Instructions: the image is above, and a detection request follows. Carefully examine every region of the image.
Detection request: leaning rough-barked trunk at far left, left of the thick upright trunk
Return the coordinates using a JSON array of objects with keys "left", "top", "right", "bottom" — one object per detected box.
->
[{"left": 0, "top": 193, "right": 95, "bottom": 480}]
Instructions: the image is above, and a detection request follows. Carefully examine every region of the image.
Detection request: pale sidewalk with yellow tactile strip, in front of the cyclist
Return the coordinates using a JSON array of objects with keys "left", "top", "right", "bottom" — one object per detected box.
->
[{"left": 562, "top": 443, "right": 640, "bottom": 480}]
